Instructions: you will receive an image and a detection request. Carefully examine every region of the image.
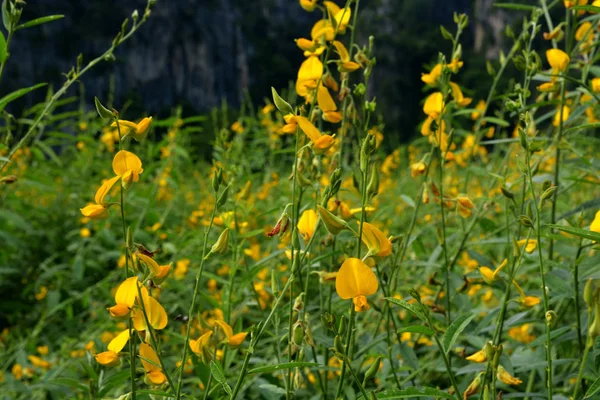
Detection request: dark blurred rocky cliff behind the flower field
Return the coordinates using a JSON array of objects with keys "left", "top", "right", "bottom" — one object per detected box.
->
[{"left": 8, "top": 0, "right": 536, "bottom": 147}]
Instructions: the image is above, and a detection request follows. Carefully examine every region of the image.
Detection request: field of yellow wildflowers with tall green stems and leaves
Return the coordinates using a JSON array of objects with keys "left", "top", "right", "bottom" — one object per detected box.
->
[{"left": 0, "top": 0, "right": 600, "bottom": 400}]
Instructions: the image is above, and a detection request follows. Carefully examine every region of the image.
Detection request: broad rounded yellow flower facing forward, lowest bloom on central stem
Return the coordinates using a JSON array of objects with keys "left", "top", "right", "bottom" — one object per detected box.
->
[{"left": 335, "top": 258, "right": 379, "bottom": 312}]
